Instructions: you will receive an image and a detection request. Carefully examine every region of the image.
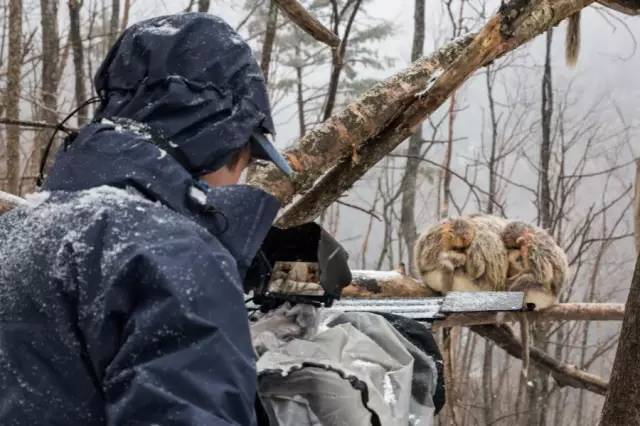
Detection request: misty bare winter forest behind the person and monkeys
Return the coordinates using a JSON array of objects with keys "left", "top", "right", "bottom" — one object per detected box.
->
[{"left": 0, "top": 0, "right": 640, "bottom": 425}]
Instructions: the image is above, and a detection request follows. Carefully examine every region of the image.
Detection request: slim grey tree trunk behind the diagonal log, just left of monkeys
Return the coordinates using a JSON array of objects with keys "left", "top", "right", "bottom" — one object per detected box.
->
[{"left": 400, "top": 0, "right": 425, "bottom": 273}]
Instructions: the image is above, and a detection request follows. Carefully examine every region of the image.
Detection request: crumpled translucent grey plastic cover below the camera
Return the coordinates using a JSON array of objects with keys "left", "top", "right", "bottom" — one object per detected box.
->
[{"left": 252, "top": 305, "right": 437, "bottom": 426}]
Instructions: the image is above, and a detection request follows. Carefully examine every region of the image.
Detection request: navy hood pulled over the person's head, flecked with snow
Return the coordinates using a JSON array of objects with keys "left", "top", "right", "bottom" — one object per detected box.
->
[{"left": 95, "top": 13, "right": 274, "bottom": 175}]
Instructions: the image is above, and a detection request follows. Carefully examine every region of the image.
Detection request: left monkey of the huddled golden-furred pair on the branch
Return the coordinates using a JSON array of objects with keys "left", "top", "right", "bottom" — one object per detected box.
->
[{"left": 414, "top": 215, "right": 508, "bottom": 294}]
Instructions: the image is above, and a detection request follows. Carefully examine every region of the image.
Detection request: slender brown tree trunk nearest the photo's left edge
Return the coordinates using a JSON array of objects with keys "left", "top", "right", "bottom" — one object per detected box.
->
[{"left": 5, "top": 0, "right": 22, "bottom": 195}]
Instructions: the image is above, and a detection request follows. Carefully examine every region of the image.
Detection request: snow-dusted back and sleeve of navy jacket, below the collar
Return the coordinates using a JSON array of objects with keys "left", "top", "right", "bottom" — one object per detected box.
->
[{"left": 0, "top": 186, "right": 276, "bottom": 425}]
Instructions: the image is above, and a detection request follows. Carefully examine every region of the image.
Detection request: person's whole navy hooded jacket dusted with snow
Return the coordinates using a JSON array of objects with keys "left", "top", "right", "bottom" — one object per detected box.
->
[{"left": 0, "top": 14, "right": 278, "bottom": 426}]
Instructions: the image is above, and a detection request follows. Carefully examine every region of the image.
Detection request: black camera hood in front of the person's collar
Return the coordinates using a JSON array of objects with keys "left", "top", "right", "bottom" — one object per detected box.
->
[{"left": 244, "top": 222, "right": 351, "bottom": 306}]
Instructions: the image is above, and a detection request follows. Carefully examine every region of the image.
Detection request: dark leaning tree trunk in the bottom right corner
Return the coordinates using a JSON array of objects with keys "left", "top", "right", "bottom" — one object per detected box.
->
[{"left": 600, "top": 257, "right": 640, "bottom": 426}]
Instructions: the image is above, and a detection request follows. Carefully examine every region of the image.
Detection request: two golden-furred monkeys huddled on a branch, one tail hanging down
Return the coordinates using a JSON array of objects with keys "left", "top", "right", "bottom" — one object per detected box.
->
[{"left": 414, "top": 215, "right": 569, "bottom": 377}]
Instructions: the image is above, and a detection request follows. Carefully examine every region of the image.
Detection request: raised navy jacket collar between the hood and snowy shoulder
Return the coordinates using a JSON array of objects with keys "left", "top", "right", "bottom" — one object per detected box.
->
[{"left": 43, "top": 123, "right": 280, "bottom": 278}]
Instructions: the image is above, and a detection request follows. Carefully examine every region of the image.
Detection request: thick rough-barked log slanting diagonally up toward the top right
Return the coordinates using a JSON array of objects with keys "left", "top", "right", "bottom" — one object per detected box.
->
[{"left": 251, "top": 0, "right": 592, "bottom": 226}]
